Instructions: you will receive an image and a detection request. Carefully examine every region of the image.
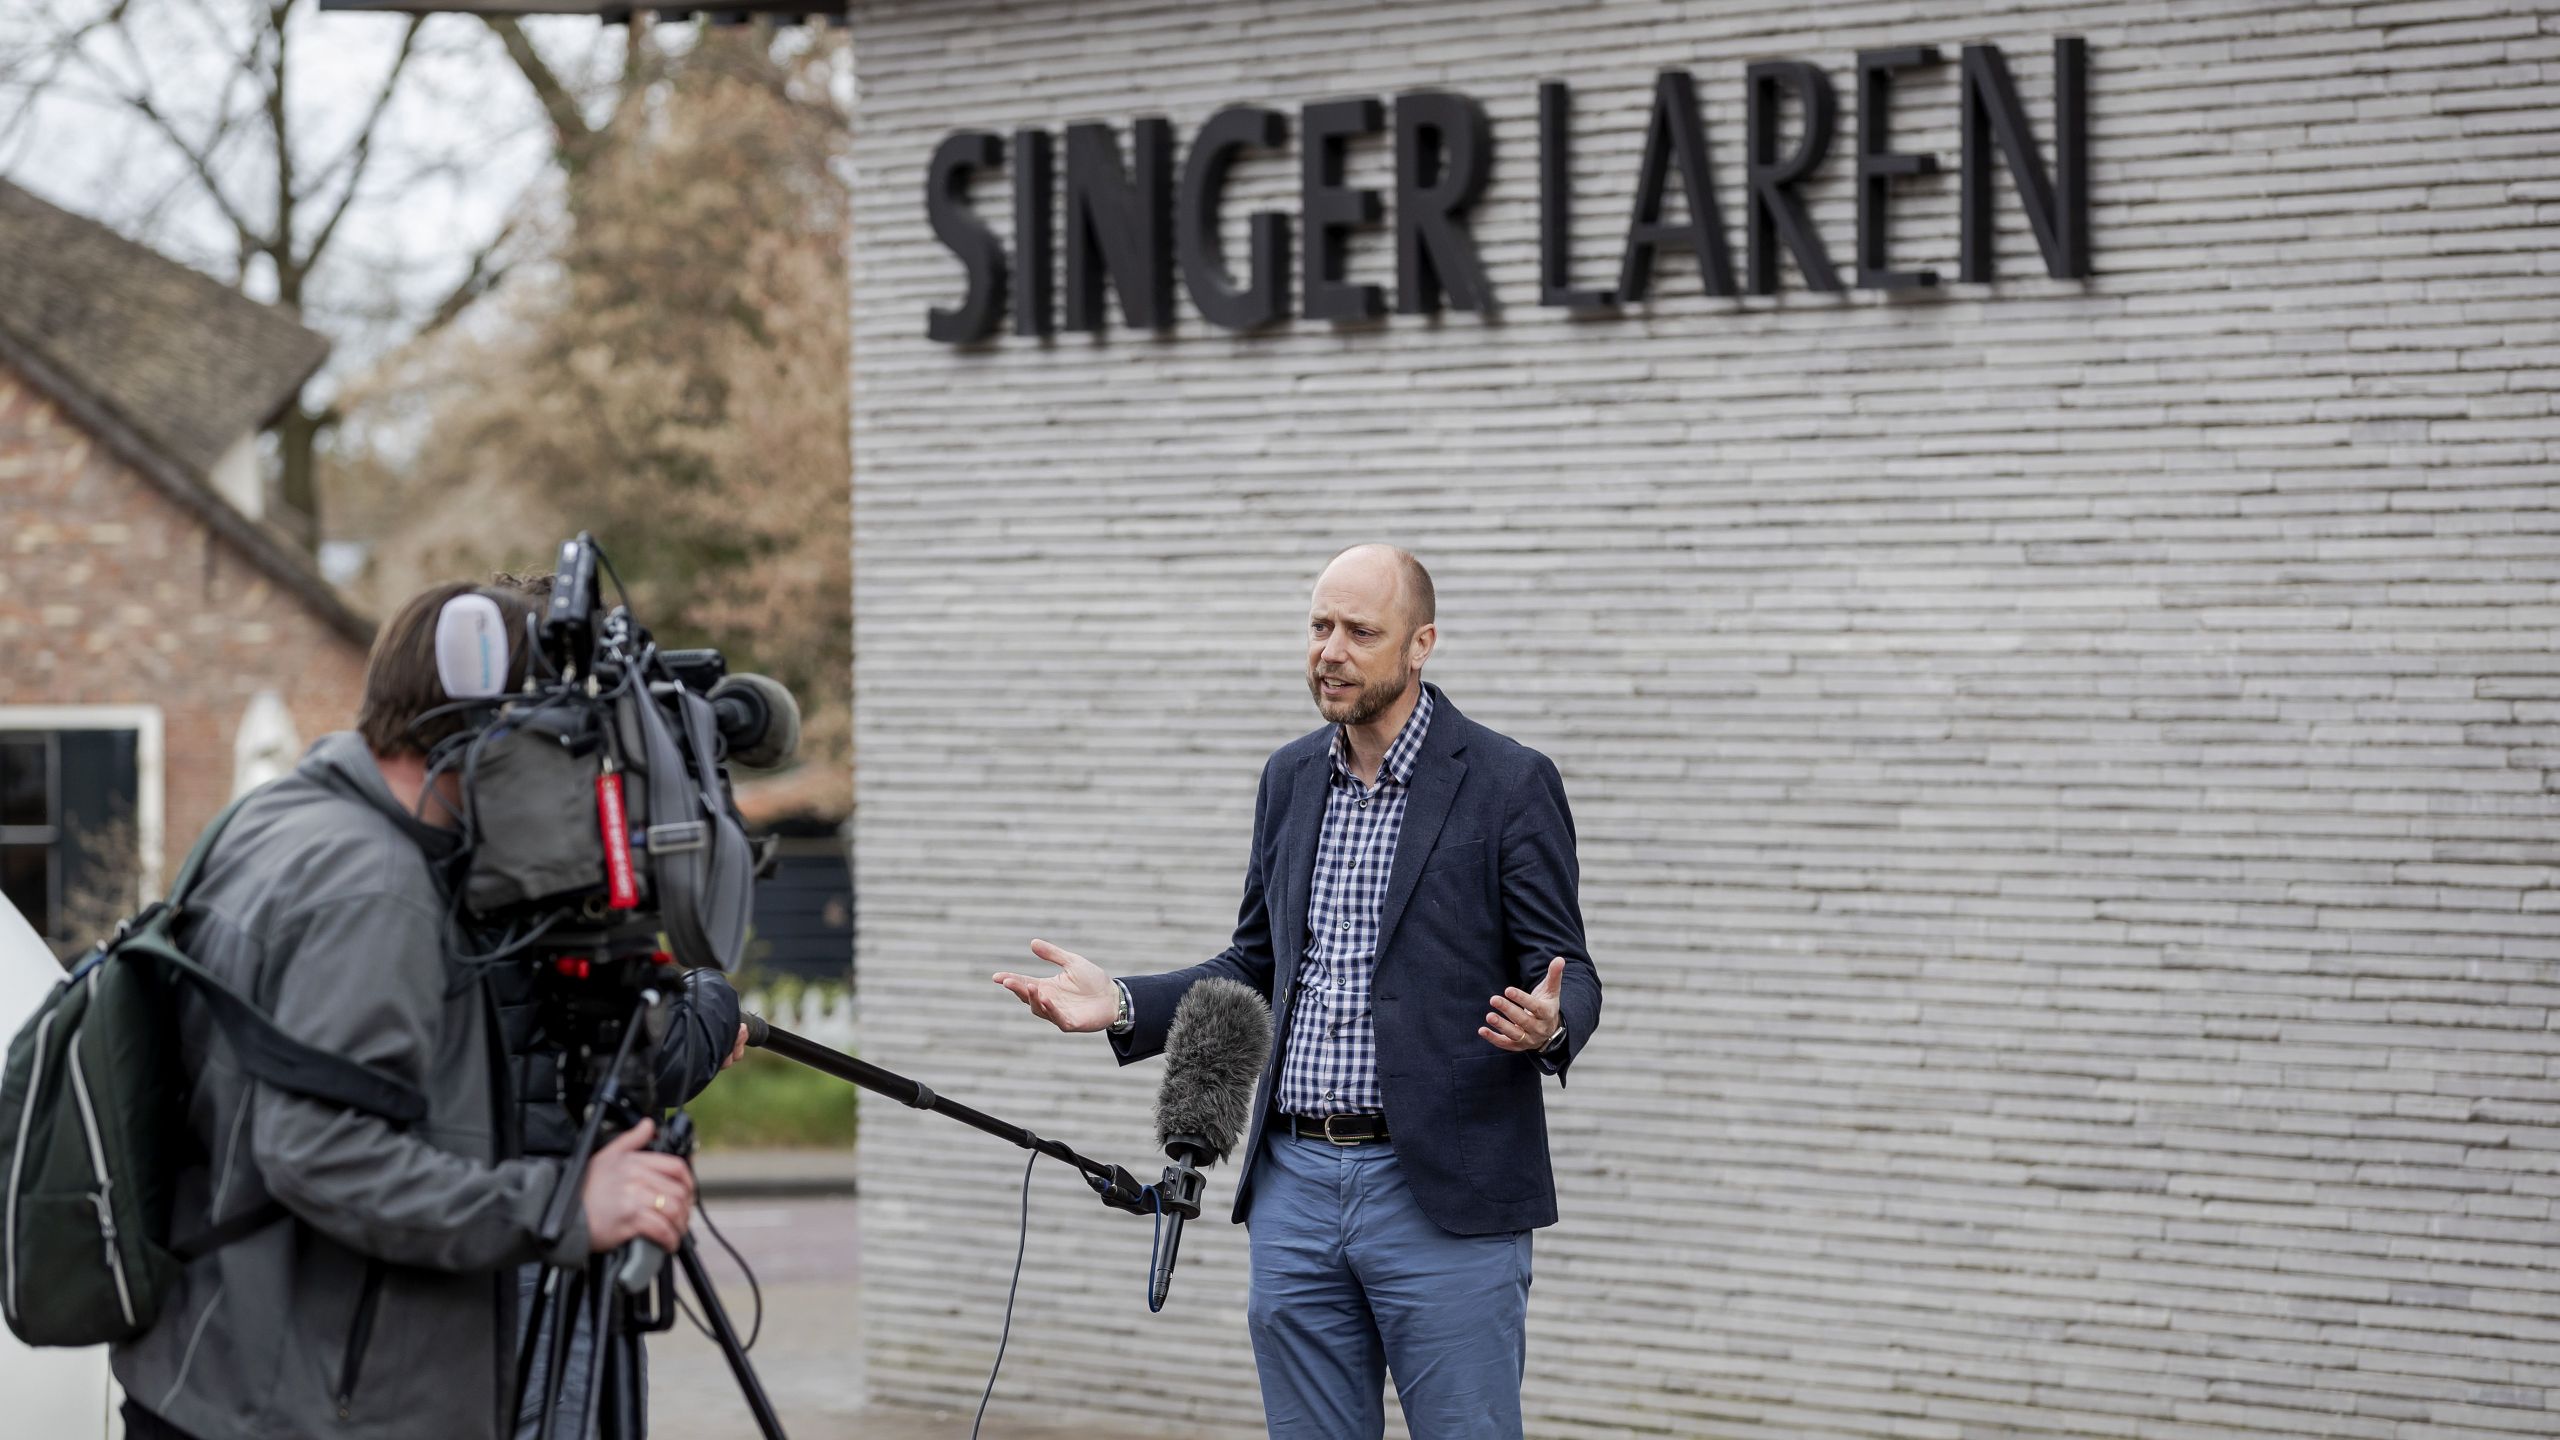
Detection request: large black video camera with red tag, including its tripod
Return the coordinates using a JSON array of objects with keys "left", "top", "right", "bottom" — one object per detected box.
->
[{"left": 430, "top": 533, "right": 799, "bottom": 1440}]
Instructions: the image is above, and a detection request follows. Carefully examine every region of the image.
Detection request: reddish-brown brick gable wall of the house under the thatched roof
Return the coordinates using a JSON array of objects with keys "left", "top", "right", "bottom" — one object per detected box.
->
[{"left": 0, "top": 366, "right": 364, "bottom": 876}]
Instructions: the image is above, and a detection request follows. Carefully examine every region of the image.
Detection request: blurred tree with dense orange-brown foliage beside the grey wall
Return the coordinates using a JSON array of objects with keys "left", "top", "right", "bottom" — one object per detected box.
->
[{"left": 333, "top": 31, "right": 852, "bottom": 761}]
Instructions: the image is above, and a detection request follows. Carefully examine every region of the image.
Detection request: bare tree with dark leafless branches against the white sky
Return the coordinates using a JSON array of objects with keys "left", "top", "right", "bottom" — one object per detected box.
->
[{"left": 0, "top": 0, "right": 565, "bottom": 543}]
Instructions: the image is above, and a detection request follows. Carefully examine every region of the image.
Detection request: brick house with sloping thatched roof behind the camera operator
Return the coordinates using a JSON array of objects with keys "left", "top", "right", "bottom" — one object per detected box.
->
[{"left": 0, "top": 182, "right": 371, "bottom": 948}]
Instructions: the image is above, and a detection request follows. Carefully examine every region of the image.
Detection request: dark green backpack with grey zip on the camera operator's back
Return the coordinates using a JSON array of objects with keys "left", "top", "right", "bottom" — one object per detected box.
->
[{"left": 0, "top": 802, "right": 428, "bottom": 1345}]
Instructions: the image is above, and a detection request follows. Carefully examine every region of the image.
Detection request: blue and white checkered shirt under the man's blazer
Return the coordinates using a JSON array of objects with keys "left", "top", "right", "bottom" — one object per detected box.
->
[{"left": 1280, "top": 689, "right": 1431, "bottom": 1115}]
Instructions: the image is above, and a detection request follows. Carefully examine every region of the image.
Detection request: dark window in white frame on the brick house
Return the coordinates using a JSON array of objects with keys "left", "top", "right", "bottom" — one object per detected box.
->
[{"left": 0, "top": 730, "right": 141, "bottom": 956}]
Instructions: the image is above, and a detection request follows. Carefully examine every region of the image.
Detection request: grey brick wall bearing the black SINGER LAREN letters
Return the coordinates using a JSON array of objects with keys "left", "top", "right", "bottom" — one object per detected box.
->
[{"left": 855, "top": 0, "right": 2560, "bottom": 1440}]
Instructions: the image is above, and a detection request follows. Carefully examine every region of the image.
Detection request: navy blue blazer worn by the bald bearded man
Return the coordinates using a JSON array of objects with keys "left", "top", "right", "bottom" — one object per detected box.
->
[{"left": 1111, "top": 687, "right": 1600, "bottom": 1235}]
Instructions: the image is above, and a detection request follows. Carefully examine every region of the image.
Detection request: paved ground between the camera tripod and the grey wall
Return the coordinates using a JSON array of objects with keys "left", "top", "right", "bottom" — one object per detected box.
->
[{"left": 648, "top": 1178, "right": 1141, "bottom": 1440}]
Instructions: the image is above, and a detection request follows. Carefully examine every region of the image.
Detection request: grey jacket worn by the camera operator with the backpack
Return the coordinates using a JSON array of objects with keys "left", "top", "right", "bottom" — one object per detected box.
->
[{"left": 115, "top": 733, "right": 586, "bottom": 1440}]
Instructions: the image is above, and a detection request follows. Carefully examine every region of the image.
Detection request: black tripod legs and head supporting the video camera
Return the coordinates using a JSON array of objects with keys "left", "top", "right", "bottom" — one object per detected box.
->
[{"left": 509, "top": 968, "right": 786, "bottom": 1440}]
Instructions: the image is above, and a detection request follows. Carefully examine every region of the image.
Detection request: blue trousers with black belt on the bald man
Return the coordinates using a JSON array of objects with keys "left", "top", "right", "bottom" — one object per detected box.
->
[{"left": 1244, "top": 1135, "right": 1528, "bottom": 1440}]
